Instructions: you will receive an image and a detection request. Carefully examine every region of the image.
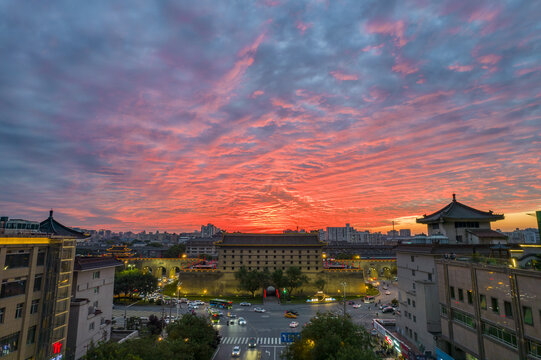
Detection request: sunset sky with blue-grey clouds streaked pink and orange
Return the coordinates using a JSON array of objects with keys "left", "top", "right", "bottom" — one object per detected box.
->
[{"left": 0, "top": 0, "right": 541, "bottom": 232}]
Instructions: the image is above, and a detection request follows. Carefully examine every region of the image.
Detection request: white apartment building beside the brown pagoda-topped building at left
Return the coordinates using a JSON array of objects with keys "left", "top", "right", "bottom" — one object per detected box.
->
[{"left": 66, "top": 256, "right": 122, "bottom": 360}]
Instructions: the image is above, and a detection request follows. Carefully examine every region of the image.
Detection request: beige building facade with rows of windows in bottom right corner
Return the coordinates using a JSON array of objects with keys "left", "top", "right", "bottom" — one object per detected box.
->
[{"left": 436, "top": 258, "right": 541, "bottom": 360}]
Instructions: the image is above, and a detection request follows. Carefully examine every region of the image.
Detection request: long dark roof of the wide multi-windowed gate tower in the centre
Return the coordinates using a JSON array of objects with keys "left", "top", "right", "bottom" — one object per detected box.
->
[{"left": 216, "top": 233, "right": 325, "bottom": 246}]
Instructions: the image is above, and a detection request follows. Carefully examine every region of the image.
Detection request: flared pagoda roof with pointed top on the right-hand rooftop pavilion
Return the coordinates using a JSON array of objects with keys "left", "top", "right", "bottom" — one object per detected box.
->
[{"left": 416, "top": 194, "right": 504, "bottom": 224}]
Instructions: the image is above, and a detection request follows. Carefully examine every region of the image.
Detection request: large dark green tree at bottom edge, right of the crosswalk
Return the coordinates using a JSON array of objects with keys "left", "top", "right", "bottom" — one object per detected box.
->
[{"left": 285, "top": 313, "right": 376, "bottom": 360}]
